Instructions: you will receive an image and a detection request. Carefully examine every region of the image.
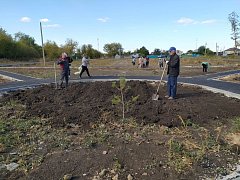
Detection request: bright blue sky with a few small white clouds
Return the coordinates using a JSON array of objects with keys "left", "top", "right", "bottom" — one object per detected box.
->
[{"left": 0, "top": 0, "right": 240, "bottom": 52}]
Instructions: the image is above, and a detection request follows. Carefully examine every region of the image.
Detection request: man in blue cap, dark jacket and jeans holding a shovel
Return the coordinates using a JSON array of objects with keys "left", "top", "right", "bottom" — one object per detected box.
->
[{"left": 165, "top": 47, "right": 180, "bottom": 99}]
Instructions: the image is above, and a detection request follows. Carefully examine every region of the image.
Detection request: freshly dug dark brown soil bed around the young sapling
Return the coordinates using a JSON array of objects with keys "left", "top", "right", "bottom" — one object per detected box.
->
[{"left": 1, "top": 81, "right": 240, "bottom": 128}]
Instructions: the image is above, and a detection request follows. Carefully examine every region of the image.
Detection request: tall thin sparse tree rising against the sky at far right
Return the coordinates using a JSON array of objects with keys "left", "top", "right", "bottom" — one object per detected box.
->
[{"left": 228, "top": 12, "right": 240, "bottom": 54}]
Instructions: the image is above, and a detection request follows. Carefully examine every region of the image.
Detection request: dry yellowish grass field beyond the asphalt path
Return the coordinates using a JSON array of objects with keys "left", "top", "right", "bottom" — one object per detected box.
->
[{"left": 0, "top": 57, "right": 240, "bottom": 78}]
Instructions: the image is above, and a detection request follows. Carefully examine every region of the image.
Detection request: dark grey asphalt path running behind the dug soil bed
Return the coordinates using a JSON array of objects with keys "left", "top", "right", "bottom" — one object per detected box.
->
[{"left": 0, "top": 70, "right": 240, "bottom": 95}]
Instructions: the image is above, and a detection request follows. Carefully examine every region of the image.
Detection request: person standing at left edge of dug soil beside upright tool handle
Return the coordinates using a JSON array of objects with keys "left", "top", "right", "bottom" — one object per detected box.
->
[{"left": 57, "top": 53, "right": 69, "bottom": 88}]
